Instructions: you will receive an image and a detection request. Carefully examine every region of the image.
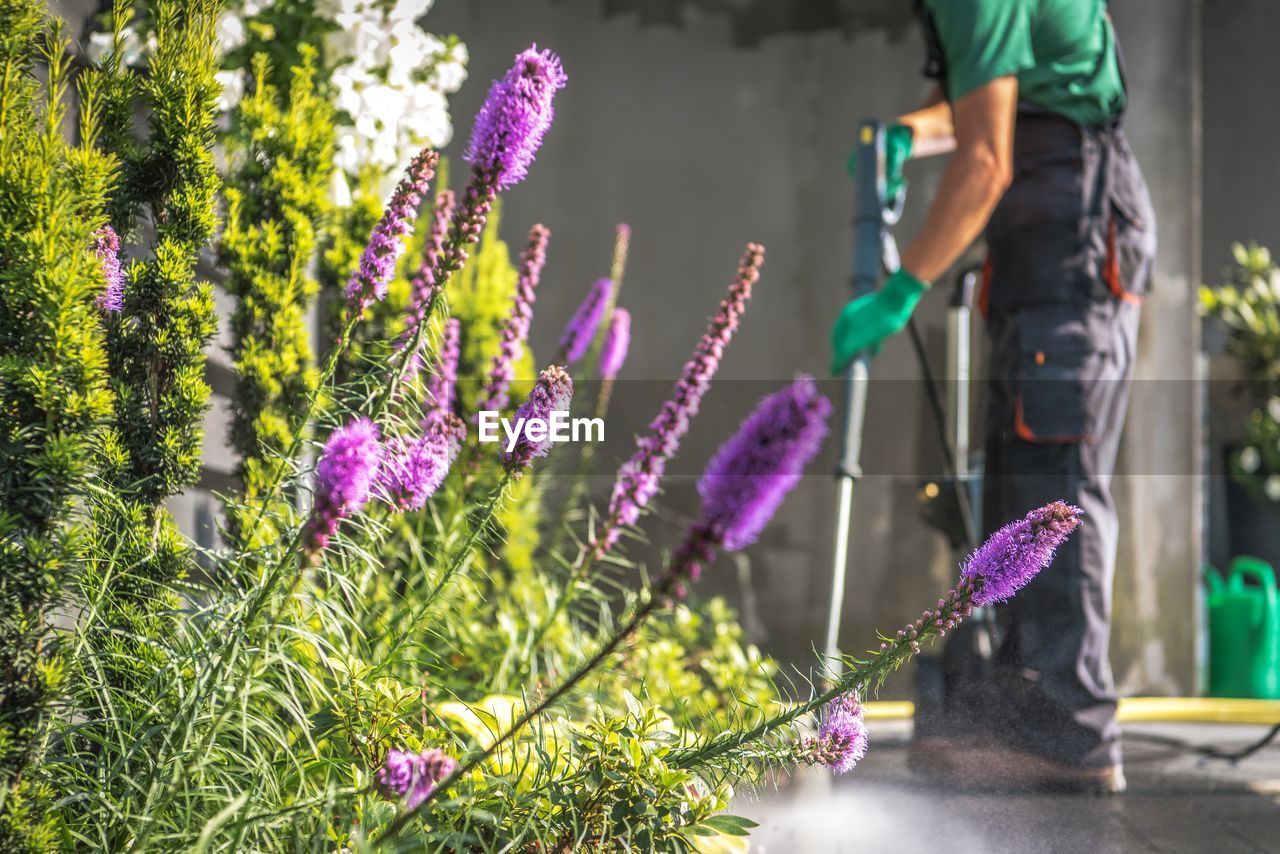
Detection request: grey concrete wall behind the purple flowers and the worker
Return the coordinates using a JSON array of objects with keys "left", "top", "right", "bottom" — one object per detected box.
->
[{"left": 426, "top": 0, "right": 1201, "bottom": 694}]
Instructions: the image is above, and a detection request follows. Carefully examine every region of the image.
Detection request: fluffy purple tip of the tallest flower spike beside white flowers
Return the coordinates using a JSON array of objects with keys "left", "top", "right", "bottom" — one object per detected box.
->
[{"left": 465, "top": 45, "right": 567, "bottom": 189}]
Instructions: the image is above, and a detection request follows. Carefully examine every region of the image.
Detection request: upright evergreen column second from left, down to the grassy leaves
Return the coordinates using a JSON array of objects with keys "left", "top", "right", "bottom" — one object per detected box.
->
[{"left": 109, "top": 0, "right": 220, "bottom": 506}]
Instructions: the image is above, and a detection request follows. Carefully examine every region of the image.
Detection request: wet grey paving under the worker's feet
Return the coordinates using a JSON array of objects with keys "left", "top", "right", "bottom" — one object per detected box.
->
[{"left": 735, "top": 721, "right": 1280, "bottom": 854}]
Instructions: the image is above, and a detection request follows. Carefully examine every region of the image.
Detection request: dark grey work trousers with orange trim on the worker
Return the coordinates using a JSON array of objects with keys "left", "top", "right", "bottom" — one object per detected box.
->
[{"left": 945, "top": 113, "right": 1155, "bottom": 767}]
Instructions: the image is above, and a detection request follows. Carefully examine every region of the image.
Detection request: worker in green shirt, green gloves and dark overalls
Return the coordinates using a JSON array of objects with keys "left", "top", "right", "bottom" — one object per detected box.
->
[{"left": 832, "top": 0, "right": 1156, "bottom": 793}]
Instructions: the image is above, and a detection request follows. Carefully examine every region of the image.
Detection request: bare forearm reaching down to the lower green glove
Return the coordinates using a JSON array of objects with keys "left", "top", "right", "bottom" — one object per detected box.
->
[{"left": 902, "top": 150, "right": 1009, "bottom": 282}]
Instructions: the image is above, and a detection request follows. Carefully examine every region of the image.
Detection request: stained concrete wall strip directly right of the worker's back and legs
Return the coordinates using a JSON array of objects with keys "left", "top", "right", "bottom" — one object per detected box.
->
[{"left": 1111, "top": 0, "right": 1204, "bottom": 693}]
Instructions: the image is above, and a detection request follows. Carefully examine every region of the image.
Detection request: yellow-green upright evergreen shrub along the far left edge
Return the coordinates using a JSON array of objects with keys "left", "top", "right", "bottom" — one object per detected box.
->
[{"left": 0, "top": 6, "right": 114, "bottom": 851}]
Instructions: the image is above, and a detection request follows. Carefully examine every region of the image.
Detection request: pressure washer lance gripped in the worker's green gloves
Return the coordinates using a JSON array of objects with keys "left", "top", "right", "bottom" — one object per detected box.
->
[{"left": 823, "top": 119, "right": 904, "bottom": 681}]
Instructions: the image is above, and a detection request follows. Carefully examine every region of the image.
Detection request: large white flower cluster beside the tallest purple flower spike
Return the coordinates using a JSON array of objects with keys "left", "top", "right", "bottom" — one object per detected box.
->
[{"left": 316, "top": 0, "right": 467, "bottom": 174}]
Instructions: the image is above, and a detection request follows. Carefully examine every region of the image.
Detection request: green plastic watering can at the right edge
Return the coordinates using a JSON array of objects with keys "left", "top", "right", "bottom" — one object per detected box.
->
[{"left": 1204, "top": 557, "right": 1280, "bottom": 699}]
